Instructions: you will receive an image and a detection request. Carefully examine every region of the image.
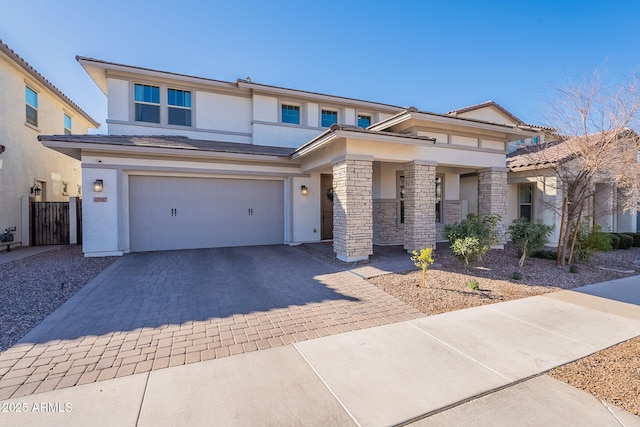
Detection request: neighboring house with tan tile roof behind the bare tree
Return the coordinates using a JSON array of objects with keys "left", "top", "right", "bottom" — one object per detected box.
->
[{"left": 507, "top": 134, "right": 637, "bottom": 241}]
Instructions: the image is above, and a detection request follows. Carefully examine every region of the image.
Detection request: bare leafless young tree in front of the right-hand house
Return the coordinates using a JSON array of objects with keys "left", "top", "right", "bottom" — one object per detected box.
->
[{"left": 509, "top": 71, "right": 640, "bottom": 264}]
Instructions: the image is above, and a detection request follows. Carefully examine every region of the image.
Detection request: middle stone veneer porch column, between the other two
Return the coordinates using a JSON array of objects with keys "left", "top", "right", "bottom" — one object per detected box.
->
[{"left": 404, "top": 161, "right": 436, "bottom": 252}]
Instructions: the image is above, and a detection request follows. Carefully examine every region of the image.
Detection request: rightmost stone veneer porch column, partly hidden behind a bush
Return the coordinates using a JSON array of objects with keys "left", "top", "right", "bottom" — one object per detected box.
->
[{"left": 478, "top": 168, "right": 508, "bottom": 245}]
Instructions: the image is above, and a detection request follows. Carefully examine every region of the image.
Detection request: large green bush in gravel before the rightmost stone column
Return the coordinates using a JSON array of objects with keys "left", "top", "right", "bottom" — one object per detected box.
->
[{"left": 443, "top": 213, "right": 500, "bottom": 269}]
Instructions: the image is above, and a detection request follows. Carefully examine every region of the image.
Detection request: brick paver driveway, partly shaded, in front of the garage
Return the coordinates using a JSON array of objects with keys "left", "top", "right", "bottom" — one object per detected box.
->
[{"left": 0, "top": 246, "right": 422, "bottom": 399}]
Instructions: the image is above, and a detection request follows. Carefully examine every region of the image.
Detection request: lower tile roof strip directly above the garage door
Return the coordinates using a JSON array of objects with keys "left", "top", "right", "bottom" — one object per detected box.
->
[{"left": 38, "top": 135, "right": 295, "bottom": 157}]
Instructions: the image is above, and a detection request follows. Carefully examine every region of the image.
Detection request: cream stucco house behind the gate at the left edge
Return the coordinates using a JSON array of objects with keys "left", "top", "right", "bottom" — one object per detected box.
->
[{"left": 0, "top": 41, "right": 99, "bottom": 246}]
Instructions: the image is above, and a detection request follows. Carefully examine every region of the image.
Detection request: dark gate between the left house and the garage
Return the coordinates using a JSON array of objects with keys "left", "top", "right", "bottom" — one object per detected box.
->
[{"left": 30, "top": 202, "right": 70, "bottom": 246}]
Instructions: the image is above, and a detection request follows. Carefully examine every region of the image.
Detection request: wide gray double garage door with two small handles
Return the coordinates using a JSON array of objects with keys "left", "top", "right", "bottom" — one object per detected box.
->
[{"left": 129, "top": 176, "right": 284, "bottom": 252}]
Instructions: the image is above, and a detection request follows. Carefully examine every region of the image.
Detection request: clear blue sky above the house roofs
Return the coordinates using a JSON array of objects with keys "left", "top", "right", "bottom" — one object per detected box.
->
[{"left": 0, "top": 0, "right": 640, "bottom": 133}]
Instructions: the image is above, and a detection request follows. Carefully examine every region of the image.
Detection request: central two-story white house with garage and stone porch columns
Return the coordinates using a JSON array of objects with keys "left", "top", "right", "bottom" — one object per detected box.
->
[{"left": 40, "top": 57, "right": 541, "bottom": 261}]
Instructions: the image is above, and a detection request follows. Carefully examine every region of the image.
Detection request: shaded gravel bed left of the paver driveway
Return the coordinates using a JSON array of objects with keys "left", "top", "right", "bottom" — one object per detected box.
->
[{"left": 0, "top": 245, "right": 117, "bottom": 353}]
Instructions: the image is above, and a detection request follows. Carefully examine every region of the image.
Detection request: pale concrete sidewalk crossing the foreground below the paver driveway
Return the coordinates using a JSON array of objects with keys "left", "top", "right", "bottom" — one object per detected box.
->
[{"left": 0, "top": 276, "right": 640, "bottom": 426}]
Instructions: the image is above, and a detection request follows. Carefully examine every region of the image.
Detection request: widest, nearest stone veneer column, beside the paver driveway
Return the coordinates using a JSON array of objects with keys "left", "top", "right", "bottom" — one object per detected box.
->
[{"left": 333, "top": 157, "right": 373, "bottom": 262}]
